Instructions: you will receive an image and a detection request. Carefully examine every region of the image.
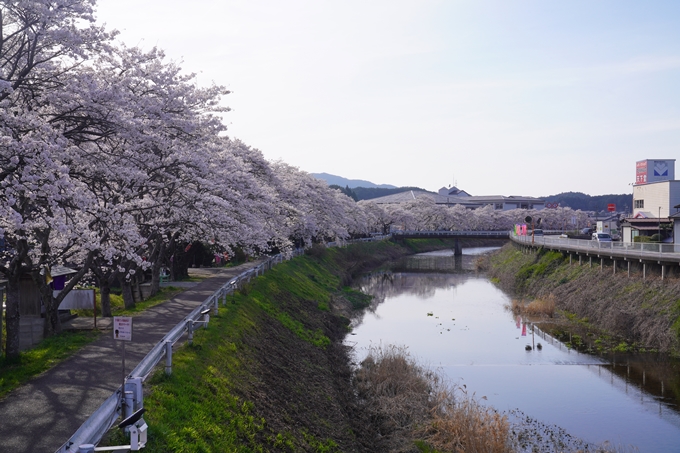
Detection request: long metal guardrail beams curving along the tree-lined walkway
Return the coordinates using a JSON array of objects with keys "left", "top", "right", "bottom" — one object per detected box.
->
[{"left": 55, "top": 235, "right": 390, "bottom": 453}]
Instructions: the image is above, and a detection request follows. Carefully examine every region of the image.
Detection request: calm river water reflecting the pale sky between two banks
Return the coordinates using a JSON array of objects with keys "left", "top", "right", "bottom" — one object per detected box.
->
[{"left": 347, "top": 248, "right": 680, "bottom": 453}]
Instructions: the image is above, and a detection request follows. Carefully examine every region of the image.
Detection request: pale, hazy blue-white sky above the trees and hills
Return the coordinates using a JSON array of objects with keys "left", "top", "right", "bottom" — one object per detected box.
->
[{"left": 97, "top": 0, "right": 680, "bottom": 196}]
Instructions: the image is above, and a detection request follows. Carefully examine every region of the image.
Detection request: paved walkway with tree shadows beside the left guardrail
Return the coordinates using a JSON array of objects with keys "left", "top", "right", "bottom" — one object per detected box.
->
[{"left": 0, "top": 263, "right": 259, "bottom": 453}]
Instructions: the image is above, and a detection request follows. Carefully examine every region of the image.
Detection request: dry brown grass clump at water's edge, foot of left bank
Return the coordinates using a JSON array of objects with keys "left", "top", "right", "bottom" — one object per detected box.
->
[{"left": 355, "top": 346, "right": 512, "bottom": 453}]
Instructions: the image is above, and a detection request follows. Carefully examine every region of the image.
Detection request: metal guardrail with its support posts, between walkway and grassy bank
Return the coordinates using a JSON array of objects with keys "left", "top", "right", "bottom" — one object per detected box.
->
[{"left": 56, "top": 235, "right": 390, "bottom": 453}]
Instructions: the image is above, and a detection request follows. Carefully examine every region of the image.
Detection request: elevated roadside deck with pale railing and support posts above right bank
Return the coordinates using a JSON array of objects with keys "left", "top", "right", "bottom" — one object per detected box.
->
[{"left": 509, "top": 233, "right": 680, "bottom": 280}]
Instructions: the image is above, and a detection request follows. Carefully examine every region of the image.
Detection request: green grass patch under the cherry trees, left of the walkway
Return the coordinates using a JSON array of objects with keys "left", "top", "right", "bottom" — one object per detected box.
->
[{"left": 0, "top": 331, "right": 100, "bottom": 398}]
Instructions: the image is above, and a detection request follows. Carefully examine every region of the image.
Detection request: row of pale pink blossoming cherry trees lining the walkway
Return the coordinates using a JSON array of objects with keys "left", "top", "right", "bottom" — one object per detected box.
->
[{"left": 0, "top": 0, "right": 588, "bottom": 357}]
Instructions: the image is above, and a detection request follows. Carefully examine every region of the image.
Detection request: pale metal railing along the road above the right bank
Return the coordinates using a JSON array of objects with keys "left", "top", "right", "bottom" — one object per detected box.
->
[{"left": 510, "top": 234, "right": 680, "bottom": 263}]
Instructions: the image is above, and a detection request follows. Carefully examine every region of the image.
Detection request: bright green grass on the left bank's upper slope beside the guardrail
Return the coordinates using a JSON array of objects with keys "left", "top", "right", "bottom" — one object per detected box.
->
[{"left": 107, "top": 257, "right": 350, "bottom": 453}]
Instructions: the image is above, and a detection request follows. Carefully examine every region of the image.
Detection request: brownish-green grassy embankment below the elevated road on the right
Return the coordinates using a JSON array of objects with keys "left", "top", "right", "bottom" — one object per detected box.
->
[{"left": 488, "top": 244, "right": 680, "bottom": 355}]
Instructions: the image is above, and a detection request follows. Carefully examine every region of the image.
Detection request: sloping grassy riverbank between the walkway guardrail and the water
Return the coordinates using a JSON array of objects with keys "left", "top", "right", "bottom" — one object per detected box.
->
[{"left": 103, "top": 240, "right": 507, "bottom": 453}]
